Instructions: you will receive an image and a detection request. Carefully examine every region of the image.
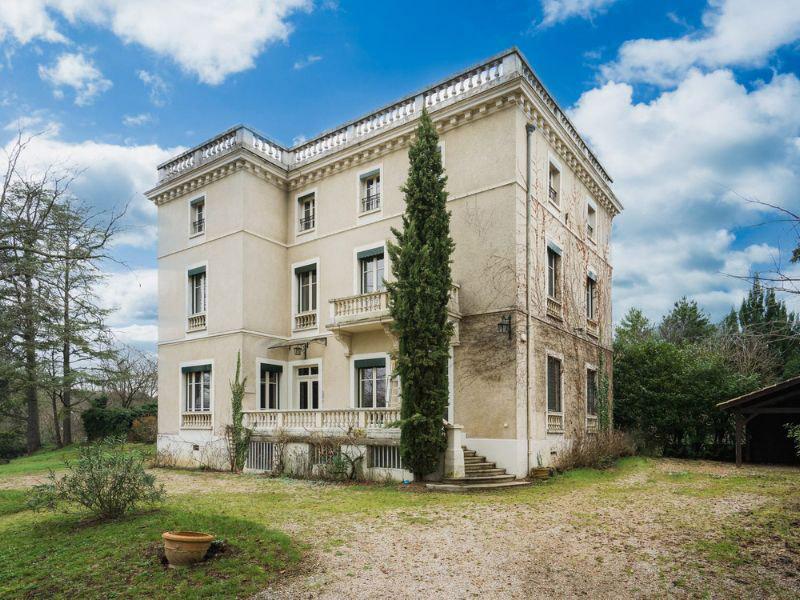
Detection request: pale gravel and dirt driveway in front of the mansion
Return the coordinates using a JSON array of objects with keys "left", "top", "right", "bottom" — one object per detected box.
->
[{"left": 259, "top": 461, "right": 800, "bottom": 599}]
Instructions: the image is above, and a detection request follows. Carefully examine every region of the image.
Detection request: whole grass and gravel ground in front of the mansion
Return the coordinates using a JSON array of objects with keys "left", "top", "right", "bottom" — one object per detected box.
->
[{"left": 0, "top": 455, "right": 800, "bottom": 598}]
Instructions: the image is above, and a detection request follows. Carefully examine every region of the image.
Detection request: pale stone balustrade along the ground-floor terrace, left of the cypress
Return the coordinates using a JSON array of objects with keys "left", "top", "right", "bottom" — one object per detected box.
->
[{"left": 244, "top": 408, "right": 400, "bottom": 432}]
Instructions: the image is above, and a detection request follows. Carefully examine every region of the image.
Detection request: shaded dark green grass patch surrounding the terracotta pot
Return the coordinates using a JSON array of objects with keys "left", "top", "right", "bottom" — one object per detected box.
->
[{"left": 0, "top": 505, "right": 301, "bottom": 598}]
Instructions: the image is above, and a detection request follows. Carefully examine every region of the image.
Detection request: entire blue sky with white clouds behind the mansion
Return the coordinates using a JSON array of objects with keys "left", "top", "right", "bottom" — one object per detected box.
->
[{"left": 0, "top": 0, "right": 800, "bottom": 347}]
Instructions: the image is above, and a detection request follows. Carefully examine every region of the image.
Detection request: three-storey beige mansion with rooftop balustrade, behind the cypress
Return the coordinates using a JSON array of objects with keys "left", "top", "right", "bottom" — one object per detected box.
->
[{"left": 147, "top": 49, "right": 622, "bottom": 479}]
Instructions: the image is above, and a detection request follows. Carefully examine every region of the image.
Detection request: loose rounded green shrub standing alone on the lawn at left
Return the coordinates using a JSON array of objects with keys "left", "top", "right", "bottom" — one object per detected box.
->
[{"left": 28, "top": 438, "right": 164, "bottom": 520}]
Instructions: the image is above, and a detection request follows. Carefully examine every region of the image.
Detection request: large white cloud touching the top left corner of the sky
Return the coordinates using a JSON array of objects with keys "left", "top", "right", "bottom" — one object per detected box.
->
[{"left": 0, "top": 0, "right": 312, "bottom": 85}]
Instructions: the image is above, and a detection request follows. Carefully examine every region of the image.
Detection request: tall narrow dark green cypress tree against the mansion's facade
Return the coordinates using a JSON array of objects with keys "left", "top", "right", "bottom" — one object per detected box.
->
[{"left": 387, "top": 109, "right": 455, "bottom": 477}]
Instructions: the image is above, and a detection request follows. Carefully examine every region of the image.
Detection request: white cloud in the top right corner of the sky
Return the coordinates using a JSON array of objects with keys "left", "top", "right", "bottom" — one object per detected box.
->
[{"left": 601, "top": 0, "right": 800, "bottom": 86}]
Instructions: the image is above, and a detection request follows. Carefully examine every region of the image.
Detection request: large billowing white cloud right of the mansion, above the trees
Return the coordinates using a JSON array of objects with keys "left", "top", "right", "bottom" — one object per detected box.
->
[{"left": 571, "top": 70, "right": 800, "bottom": 319}]
